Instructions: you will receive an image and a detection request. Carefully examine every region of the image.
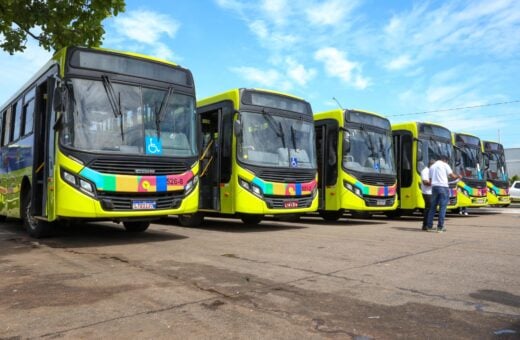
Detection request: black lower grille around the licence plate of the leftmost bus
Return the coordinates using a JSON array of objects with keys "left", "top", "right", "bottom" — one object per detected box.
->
[{"left": 98, "top": 191, "right": 183, "bottom": 211}]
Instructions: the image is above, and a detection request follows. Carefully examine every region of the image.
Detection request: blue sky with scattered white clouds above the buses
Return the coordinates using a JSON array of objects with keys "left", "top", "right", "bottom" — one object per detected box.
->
[{"left": 0, "top": 0, "right": 520, "bottom": 148}]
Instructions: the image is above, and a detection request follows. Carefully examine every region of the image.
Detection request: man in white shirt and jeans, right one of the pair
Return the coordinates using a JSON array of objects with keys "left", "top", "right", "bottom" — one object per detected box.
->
[{"left": 426, "top": 155, "right": 461, "bottom": 232}]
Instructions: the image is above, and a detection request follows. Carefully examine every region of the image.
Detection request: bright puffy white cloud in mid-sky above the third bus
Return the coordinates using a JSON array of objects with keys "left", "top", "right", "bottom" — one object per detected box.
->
[{"left": 314, "top": 47, "right": 370, "bottom": 90}]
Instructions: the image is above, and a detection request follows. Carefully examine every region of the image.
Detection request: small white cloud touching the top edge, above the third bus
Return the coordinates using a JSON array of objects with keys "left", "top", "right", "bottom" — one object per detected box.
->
[{"left": 305, "top": 0, "right": 357, "bottom": 25}]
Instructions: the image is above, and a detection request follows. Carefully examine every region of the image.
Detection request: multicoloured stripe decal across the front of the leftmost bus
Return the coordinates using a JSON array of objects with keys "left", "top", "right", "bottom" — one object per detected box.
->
[{"left": 79, "top": 168, "right": 194, "bottom": 192}]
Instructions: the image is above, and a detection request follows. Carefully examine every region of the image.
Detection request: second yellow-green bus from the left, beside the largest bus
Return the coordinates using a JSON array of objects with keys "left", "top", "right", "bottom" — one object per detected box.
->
[{"left": 179, "top": 88, "right": 318, "bottom": 226}]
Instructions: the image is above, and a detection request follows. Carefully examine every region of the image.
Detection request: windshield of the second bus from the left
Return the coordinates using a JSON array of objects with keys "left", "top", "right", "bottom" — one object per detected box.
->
[{"left": 237, "top": 111, "right": 316, "bottom": 169}]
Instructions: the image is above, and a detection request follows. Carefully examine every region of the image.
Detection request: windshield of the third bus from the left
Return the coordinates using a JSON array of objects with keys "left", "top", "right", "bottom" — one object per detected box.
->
[{"left": 343, "top": 127, "right": 396, "bottom": 175}]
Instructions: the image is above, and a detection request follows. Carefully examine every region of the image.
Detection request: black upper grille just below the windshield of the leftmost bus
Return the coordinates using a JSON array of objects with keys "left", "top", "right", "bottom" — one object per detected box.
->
[{"left": 87, "top": 158, "right": 188, "bottom": 176}]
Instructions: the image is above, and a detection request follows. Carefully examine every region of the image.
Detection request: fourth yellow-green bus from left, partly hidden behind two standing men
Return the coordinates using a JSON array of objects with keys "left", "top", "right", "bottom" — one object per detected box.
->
[{"left": 392, "top": 122, "right": 458, "bottom": 216}]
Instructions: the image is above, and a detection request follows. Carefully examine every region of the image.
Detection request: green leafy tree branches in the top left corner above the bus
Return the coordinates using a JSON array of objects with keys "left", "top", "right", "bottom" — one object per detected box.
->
[{"left": 0, "top": 0, "right": 125, "bottom": 54}]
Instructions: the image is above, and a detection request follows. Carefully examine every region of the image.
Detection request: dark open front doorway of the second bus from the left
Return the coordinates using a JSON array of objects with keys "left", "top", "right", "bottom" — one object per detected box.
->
[{"left": 199, "top": 109, "right": 222, "bottom": 211}]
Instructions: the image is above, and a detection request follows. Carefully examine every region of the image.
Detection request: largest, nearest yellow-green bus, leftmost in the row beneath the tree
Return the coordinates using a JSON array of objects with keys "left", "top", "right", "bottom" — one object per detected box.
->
[{"left": 0, "top": 47, "right": 199, "bottom": 237}]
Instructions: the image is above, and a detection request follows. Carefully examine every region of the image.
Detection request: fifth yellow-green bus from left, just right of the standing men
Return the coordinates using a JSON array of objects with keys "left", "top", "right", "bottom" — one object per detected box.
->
[{"left": 452, "top": 132, "right": 487, "bottom": 208}]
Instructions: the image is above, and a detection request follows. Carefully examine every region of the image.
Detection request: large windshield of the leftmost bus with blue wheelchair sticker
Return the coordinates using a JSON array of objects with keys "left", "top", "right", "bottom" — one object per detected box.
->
[{"left": 60, "top": 79, "right": 197, "bottom": 157}]
